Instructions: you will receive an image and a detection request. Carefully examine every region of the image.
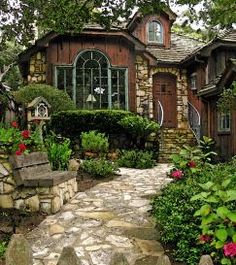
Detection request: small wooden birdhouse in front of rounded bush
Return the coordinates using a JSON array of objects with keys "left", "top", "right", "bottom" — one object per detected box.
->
[{"left": 27, "top": 97, "right": 51, "bottom": 122}]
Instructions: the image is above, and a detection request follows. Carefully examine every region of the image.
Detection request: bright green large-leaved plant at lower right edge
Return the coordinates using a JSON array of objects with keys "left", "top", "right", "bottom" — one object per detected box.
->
[{"left": 191, "top": 163, "right": 236, "bottom": 264}]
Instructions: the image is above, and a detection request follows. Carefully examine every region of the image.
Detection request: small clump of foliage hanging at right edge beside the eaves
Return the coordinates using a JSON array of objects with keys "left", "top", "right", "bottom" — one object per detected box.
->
[{"left": 217, "top": 81, "right": 236, "bottom": 113}]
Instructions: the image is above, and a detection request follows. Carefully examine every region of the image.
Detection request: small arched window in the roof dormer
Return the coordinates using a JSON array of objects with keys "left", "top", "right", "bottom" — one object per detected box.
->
[{"left": 148, "top": 21, "right": 163, "bottom": 44}]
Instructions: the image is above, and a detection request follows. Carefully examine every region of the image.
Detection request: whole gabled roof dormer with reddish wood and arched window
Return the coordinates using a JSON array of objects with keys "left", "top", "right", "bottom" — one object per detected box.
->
[{"left": 127, "top": 8, "right": 176, "bottom": 49}]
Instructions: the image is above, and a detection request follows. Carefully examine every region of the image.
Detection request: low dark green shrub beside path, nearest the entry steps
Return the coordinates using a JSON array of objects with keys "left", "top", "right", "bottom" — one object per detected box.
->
[{"left": 117, "top": 150, "right": 155, "bottom": 169}]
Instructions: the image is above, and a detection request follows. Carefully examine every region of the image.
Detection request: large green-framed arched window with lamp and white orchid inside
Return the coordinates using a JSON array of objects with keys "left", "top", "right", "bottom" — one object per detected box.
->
[{"left": 55, "top": 50, "right": 128, "bottom": 109}]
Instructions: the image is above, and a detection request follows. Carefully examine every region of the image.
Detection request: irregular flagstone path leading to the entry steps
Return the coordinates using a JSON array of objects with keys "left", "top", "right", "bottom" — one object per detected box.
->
[{"left": 27, "top": 164, "right": 170, "bottom": 265}]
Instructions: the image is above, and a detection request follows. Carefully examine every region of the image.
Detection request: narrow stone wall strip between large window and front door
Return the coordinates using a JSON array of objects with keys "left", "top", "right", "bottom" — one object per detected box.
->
[{"left": 136, "top": 55, "right": 153, "bottom": 118}]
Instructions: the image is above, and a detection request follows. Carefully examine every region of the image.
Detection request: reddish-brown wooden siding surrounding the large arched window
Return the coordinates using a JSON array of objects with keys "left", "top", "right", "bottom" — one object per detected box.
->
[{"left": 47, "top": 35, "right": 136, "bottom": 111}]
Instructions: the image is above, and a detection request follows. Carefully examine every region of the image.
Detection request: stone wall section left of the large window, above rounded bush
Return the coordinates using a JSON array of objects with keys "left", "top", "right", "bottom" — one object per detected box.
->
[{"left": 27, "top": 52, "right": 47, "bottom": 83}]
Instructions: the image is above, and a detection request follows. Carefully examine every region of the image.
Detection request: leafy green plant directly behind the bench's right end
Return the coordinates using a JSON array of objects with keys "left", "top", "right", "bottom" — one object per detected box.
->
[{"left": 45, "top": 133, "right": 72, "bottom": 170}]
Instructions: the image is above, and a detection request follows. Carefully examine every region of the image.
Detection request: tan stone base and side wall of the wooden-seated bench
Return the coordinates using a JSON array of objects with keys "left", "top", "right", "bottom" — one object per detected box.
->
[{"left": 0, "top": 154, "right": 77, "bottom": 214}]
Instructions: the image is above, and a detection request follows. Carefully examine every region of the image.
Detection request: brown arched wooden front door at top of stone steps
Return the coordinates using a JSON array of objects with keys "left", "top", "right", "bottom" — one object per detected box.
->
[{"left": 153, "top": 73, "right": 177, "bottom": 128}]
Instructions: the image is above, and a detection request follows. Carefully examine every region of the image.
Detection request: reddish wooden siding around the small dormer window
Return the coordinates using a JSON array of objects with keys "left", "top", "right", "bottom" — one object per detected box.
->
[{"left": 133, "top": 15, "right": 171, "bottom": 48}]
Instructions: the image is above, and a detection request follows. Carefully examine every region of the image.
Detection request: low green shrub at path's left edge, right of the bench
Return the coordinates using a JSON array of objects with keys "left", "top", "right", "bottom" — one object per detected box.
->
[{"left": 81, "top": 158, "right": 118, "bottom": 178}]
